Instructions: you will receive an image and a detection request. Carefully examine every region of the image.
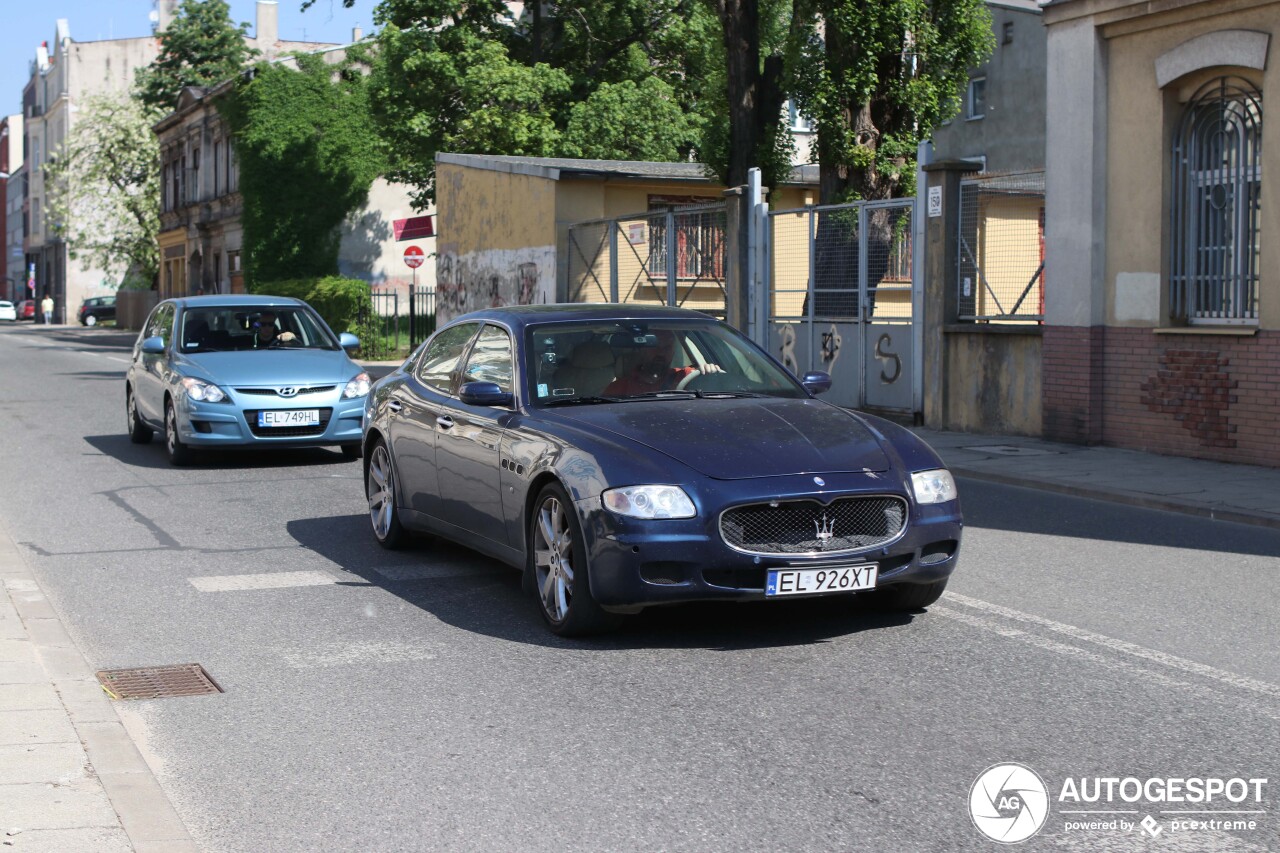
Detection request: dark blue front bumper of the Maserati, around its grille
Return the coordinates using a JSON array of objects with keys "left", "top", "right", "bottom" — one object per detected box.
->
[{"left": 575, "top": 474, "right": 964, "bottom": 611}]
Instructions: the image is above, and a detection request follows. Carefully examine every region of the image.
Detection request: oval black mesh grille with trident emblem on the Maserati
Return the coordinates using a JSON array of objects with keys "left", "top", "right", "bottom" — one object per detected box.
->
[{"left": 721, "top": 496, "right": 906, "bottom": 555}]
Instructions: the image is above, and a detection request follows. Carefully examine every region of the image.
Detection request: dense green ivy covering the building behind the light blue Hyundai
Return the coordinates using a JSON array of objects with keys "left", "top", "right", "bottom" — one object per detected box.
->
[{"left": 219, "top": 47, "right": 387, "bottom": 287}]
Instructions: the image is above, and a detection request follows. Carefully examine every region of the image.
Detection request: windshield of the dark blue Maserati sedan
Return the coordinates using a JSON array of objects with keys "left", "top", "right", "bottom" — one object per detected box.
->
[{"left": 525, "top": 320, "right": 806, "bottom": 406}]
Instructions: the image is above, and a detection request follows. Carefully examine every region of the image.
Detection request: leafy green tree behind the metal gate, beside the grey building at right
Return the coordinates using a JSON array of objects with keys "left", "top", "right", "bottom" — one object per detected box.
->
[{"left": 787, "top": 0, "right": 995, "bottom": 204}]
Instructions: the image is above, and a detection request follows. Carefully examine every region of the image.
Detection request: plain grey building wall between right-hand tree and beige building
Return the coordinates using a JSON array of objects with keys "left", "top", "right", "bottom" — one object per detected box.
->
[{"left": 933, "top": 3, "right": 1046, "bottom": 172}]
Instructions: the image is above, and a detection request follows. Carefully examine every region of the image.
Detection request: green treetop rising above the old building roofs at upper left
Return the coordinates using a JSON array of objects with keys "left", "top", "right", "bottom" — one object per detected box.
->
[{"left": 133, "top": 0, "right": 257, "bottom": 113}]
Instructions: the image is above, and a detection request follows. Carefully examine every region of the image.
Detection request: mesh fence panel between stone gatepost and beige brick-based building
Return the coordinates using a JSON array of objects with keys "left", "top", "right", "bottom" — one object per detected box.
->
[{"left": 956, "top": 172, "right": 1044, "bottom": 323}]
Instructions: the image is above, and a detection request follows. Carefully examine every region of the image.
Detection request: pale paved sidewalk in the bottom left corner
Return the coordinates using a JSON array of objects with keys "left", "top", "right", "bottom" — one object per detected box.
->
[{"left": 0, "top": 530, "right": 197, "bottom": 853}]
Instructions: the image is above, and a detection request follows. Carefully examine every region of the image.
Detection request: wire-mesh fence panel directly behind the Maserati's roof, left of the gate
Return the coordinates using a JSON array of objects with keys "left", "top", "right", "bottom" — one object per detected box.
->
[{"left": 568, "top": 204, "right": 726, "bottom": 316}]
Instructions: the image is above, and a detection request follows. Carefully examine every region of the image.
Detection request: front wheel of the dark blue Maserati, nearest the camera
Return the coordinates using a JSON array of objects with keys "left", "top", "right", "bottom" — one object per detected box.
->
[{"left": 525, "top": 483, "right": 623, "bottom": 637}]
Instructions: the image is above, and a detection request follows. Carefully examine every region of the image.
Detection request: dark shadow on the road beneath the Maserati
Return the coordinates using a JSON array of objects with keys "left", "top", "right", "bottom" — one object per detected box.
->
[{"left": 287, "top": 515, "right": 914, "bottom": 652}]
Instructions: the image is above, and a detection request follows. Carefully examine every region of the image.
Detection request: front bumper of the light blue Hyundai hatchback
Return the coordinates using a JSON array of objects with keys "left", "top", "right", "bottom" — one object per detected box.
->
[{"left": 177, "top": 383, "right": 365, "bottom": 448}]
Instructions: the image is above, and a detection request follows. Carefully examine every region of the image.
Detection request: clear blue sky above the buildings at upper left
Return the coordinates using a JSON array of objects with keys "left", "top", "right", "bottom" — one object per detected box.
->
[{"left": 0, "top": 0, "right": 378, "bottom": 115}]
